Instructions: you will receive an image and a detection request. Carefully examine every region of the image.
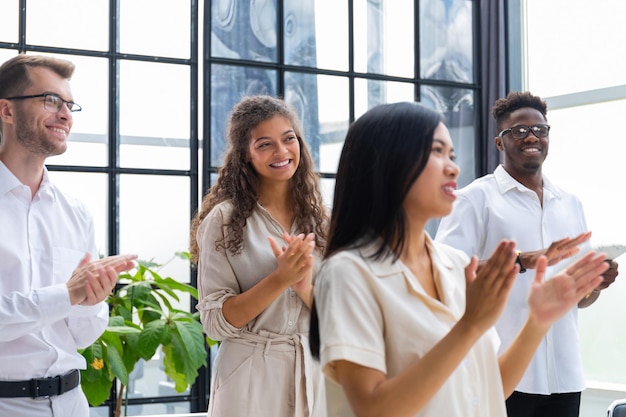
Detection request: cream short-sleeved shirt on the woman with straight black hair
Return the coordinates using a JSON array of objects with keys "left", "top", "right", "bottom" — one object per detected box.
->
[{"left": 315, "top": 236, "right": 506, "bottom": 417}]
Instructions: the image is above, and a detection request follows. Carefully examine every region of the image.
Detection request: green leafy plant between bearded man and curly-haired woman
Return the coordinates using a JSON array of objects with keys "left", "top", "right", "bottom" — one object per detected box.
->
[{"left": 80, "top": 252, "right": 214, "bottom": 417}]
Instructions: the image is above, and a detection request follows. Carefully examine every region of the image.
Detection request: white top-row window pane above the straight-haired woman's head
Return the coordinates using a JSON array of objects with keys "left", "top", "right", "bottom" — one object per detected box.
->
[{"left": 354, "top": 0, "right": 415, "bottom": 77}]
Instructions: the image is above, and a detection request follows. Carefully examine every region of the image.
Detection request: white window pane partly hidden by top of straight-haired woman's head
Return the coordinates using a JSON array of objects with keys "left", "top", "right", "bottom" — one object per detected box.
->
[{"left": 354, "top": 78, "right": 415, "bottom": 119}]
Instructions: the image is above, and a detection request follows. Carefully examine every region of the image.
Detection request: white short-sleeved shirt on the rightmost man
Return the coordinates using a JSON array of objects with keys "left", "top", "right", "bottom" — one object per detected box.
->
[{"left": 435, "top": 166, "right": 589, "bottom": 395}]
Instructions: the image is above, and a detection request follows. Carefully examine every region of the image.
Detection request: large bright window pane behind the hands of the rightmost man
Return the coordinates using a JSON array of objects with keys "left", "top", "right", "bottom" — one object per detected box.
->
[{"left": 543, "top": 100, "right": 626, "bottom": 389}]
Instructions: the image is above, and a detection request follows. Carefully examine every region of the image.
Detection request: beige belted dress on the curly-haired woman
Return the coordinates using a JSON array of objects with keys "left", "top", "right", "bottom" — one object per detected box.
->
[{"left": 196, "top": 202, "right": 326, "bottom": 417}]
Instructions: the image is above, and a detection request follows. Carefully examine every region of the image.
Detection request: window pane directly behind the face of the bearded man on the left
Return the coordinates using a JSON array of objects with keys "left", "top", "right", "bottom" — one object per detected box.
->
[{"left": 44, "top": 54, "right": 109, "bottom": 166}]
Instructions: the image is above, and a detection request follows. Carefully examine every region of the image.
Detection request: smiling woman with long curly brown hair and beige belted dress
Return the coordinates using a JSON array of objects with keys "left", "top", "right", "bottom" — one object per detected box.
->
[{"left": 191, "top": 96, "right": 328, "bottom": 417}]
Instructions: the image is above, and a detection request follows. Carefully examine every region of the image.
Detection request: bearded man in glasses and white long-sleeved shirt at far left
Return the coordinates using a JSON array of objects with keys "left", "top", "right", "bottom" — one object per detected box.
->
[{"left": 0, "top": 55, "right": 136, "bottom": 417}]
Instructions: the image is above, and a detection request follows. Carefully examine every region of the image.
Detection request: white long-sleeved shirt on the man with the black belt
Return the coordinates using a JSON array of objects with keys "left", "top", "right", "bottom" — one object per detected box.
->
[{"left": 0, "top": 162, "right": 108, "bottom": 380}]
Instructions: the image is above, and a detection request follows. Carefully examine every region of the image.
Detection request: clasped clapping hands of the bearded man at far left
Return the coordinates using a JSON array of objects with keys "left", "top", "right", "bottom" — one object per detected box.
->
[{"left": 67, "top": 253, "right": 137, "bottom": 306}]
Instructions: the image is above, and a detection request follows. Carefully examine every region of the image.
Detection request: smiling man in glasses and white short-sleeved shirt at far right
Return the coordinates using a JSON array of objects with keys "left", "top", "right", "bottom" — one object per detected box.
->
[{"left": 436, "top": 92, "right": 618, "bottom": 417}]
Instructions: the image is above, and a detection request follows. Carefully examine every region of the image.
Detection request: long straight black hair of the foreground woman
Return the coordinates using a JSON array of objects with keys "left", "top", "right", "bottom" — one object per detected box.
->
[{"left": 325, "top": 102, "right": 443, "bottom": 258}]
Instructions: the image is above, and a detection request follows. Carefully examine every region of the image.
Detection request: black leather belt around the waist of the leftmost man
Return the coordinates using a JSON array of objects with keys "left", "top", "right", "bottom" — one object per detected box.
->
[{"left": 0, "top": 369, "right": 80, "bottom": 398}]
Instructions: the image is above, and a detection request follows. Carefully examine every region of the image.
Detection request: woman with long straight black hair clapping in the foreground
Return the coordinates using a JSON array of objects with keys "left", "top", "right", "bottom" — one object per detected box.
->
[{"left": 310, "top": 103, "right": 608, "bottom": 417}]
